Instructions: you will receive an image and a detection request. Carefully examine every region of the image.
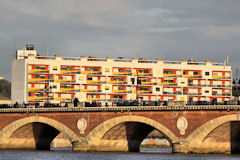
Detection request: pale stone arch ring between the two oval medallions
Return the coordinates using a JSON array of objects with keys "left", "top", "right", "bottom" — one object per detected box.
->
[{"left": 86, "top": 115, "right": 178, "bottom": 145}]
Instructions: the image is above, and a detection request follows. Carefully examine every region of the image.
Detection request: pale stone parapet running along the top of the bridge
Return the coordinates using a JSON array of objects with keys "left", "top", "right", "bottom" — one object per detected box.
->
[{"left": 0, "top": 105, "right": 240, "bottom": 113}]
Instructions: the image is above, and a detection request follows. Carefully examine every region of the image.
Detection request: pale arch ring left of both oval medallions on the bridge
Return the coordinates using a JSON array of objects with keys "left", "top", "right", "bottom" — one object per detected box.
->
[{"left": 0, "top": 116, "right": 78, "bottom": 142}]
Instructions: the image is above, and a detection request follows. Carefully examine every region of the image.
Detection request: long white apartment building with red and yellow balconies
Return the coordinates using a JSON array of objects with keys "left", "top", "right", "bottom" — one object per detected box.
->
[{"left": 12, "top": 45, "right": 232, "bottom": 105}]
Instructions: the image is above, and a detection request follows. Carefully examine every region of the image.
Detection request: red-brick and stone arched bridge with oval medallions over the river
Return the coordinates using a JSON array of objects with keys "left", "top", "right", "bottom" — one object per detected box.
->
[{"left": 0, "top": 105, "right": 240, "bottom": 153}]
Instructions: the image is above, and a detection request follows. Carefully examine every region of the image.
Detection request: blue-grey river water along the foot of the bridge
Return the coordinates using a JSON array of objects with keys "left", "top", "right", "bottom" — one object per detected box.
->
[{"left": 0, "top": 149, "right": 240, "bottom": 160}]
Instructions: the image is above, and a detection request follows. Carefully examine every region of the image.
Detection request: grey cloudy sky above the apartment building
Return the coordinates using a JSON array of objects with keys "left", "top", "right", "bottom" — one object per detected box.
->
[{"left": 0, "top": 0, "right": 240, "bottom": 81}]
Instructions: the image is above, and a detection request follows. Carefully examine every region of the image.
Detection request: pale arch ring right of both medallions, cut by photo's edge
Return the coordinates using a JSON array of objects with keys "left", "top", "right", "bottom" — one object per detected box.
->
[{"left": 186, "top": 114, "right": 240, "bottom": 145}]
